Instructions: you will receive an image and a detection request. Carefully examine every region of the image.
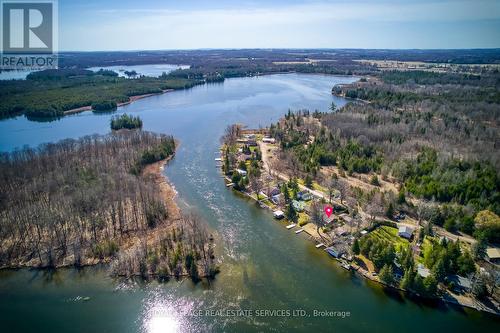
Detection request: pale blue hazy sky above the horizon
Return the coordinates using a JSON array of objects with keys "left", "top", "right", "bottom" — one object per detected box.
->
[{"left": 58, "top": 0, "right": 500, "bottom": 51}]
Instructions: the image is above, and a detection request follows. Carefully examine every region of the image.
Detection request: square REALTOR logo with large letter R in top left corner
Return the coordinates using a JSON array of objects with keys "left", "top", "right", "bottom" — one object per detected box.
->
[{"left": 0, "top": 0, "right": 57, "bottom": 69}]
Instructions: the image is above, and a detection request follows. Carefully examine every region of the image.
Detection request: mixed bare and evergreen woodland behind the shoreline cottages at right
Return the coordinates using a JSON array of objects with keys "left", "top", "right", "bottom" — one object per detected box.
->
[{"left": 270, "top": 71, "right": 500, "bottom": 242}]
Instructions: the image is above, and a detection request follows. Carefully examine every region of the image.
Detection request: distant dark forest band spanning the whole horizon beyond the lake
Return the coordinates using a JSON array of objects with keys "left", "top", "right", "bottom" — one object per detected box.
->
[{"left": 0, "top": 49, "right": 500, "bottom": 120}]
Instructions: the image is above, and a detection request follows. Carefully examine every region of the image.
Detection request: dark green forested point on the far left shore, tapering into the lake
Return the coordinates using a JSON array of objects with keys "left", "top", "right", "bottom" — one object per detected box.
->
[{"left": 0, "top": 69, "right": 203, "bottom": 119}]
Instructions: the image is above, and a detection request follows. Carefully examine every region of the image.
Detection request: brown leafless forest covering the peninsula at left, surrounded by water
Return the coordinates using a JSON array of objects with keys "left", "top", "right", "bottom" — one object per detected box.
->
[{"left": 0, "top": 130, "right": 215, "bottom": 279}]
